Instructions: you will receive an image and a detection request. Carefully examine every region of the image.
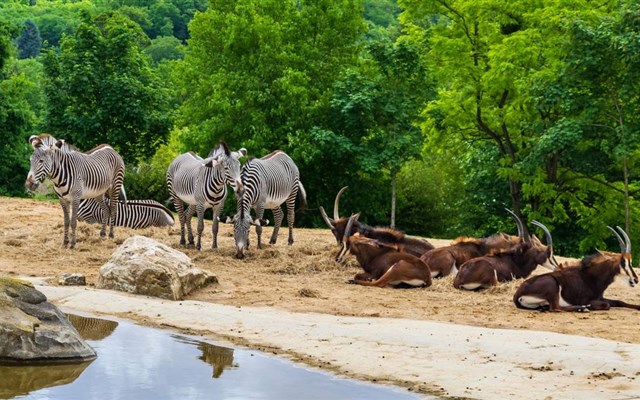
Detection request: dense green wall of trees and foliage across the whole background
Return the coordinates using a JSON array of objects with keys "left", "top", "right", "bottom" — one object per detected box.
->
[{"left": 0, "top": 0, "right": 640, "bottom": 254}]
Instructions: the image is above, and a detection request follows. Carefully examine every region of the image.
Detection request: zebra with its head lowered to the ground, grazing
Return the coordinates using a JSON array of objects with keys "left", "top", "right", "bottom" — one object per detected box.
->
[{"left": 231, "top": 150, "right": 307, "bottom": 258}]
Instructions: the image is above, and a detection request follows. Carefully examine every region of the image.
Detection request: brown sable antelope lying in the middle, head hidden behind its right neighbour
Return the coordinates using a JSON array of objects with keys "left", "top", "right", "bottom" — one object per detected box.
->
[{"left": 420, "top": 233, "right": 520, "bottom": 278}]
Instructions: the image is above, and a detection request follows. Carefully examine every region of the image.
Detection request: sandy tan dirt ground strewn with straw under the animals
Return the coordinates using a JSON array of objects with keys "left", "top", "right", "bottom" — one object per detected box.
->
[{"left": 0, "top": 197, "right": 640, "bottom": 344}]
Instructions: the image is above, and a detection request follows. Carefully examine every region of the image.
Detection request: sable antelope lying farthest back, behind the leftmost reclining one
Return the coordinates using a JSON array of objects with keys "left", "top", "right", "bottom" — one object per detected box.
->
[{"left": 320, "top": 186, "right": 434, "bottom": 257}]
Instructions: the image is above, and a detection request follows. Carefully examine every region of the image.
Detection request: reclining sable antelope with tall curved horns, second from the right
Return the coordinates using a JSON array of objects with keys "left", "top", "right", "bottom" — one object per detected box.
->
[{"left": 453, "top": 210, "right": 558, "bottom": 290}]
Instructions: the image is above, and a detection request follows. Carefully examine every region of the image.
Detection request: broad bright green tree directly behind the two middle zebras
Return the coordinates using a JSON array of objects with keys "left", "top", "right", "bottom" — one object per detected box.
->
[{"left": 176, "top": 0, "right": 362, "bottom": 154}]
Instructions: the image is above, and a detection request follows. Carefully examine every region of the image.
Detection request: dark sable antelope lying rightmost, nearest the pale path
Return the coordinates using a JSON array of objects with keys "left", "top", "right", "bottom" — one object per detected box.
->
[{"left": 513, "top": 226, "right": 640, "bottom": 311}]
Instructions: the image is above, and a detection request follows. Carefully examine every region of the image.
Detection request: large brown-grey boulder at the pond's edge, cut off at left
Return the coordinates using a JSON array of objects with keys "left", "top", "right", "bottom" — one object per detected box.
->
[{"left": 0, "top": 276, "right": 96, "bottom": 363}]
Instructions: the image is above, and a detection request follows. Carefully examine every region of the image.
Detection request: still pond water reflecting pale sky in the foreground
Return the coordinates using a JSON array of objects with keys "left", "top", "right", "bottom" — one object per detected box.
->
[{"left": 5, "top": 317, "right": 424, "bottom": 400}]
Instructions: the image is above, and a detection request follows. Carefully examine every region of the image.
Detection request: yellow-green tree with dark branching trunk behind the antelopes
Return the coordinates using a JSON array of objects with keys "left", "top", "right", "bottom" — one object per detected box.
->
[{"left": 400, "top": 0, "right": 611, "bottom": 234}]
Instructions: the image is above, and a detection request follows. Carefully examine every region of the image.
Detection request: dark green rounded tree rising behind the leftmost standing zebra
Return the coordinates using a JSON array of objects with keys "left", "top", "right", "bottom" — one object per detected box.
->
[{"left": 44, "top": 13, "right": 171, "bottom": 163}]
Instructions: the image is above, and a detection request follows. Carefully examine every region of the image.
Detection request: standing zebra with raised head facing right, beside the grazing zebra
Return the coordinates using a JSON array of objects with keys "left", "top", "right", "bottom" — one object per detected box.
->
[{"left": 167, "top": 141, "right": 247, "bottom": 250}]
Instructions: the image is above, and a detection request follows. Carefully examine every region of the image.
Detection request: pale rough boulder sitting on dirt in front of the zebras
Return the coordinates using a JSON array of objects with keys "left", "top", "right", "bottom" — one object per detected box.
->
[{"left": 97, "top": 236, "right": 218, "bottom": 300}]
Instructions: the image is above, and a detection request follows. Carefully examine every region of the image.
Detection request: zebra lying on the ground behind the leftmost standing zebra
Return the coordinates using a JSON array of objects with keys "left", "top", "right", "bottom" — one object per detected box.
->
[{"left": 78, "top": 199, "right": 175, "bottom": 229}]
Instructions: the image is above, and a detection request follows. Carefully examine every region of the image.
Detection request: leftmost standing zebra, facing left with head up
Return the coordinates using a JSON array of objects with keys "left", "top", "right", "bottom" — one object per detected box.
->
[{"left": 25, "top": 136, "right": 125, "bottom": 248}]
